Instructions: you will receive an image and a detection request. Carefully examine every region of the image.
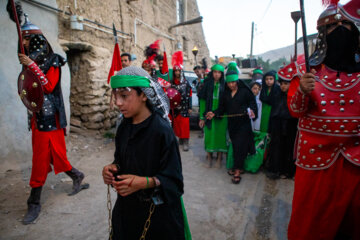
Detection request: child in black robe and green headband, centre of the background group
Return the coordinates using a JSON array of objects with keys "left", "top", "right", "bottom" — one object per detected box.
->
[{"left": 208, "top": 70, "right": 257, "bottom": 184}]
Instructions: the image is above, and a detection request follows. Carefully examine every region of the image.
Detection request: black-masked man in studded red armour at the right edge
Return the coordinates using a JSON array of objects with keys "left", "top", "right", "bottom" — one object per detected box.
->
[{"left": 280, "top": 0, "right": 360, "bottom": 240}]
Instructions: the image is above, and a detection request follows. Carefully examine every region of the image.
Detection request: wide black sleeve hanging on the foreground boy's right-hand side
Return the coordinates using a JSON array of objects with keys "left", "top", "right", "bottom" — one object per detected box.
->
[{"left": 155, "top": 133, "right": 184, "bottom": 204}]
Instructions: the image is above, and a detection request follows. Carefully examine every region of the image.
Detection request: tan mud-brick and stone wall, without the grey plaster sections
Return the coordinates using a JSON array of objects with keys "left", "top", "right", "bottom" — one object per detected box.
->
[{"left": 57, "top": 0, "right": 210, "bottom": 131}]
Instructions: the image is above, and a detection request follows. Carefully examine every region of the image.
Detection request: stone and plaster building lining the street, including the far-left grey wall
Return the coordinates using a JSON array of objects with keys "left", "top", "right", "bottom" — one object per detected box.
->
[{"left": 0, "top": 0, "right": 210, "bottom": 164}]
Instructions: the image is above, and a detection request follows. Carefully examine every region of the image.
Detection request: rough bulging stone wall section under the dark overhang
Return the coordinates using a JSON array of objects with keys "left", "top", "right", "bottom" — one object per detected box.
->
[{"left": 61, "top": 41, "right": 118, "bottom": 132}]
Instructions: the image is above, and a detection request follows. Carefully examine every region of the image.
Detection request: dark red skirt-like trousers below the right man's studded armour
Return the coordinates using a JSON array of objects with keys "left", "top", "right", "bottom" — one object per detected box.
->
[{"left": 288, "top": 155, "right": 360, "bottom": 240}]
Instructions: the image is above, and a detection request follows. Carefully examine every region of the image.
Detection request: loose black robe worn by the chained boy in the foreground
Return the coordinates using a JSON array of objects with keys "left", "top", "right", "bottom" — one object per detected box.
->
[{"left": 112, "top": 112, "right": 184, "bottom": 239}]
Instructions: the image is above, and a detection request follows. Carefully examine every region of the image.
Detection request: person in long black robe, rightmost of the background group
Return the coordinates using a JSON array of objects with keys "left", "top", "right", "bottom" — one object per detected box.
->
[{"left": 266, "top": 78, "right": 298, "bottom": 179}]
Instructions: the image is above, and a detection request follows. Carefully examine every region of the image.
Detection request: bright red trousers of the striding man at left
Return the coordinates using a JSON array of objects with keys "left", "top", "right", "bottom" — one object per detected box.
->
[{"left": 30, "top": 124, "right": 72, "bottom": 188}]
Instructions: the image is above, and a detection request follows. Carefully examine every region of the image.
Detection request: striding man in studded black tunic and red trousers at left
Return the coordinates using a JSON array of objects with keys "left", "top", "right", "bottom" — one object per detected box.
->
[{"left": 19, "top": 13, "right": 89, "bottom": 224}]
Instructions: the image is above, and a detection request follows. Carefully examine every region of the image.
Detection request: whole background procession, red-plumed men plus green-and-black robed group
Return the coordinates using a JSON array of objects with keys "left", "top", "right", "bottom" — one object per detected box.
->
[{"left": 122, "top": 41, "right": 297, "bottom": 184}]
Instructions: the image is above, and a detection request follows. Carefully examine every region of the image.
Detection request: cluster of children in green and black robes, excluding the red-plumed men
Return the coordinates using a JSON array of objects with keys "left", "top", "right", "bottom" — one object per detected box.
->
[{"left": 190, "top": 62, "right": 297, "bottom": 184}]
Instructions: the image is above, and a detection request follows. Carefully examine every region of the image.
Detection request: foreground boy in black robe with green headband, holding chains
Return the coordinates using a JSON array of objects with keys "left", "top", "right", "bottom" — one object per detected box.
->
[{"left": 103, "top": 67, "right": 185, "bottom": 240}]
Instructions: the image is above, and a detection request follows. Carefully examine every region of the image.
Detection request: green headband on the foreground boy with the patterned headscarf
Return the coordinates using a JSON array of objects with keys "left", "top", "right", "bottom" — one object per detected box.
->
[{"left": 110, "top": 75, "right": 150, "bottom": 88}]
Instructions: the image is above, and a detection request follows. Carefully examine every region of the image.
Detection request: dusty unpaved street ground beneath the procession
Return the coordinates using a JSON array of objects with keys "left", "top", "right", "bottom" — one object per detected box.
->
[{"left": 0, "top": 132, "right": 293, "bottom": 240}]
